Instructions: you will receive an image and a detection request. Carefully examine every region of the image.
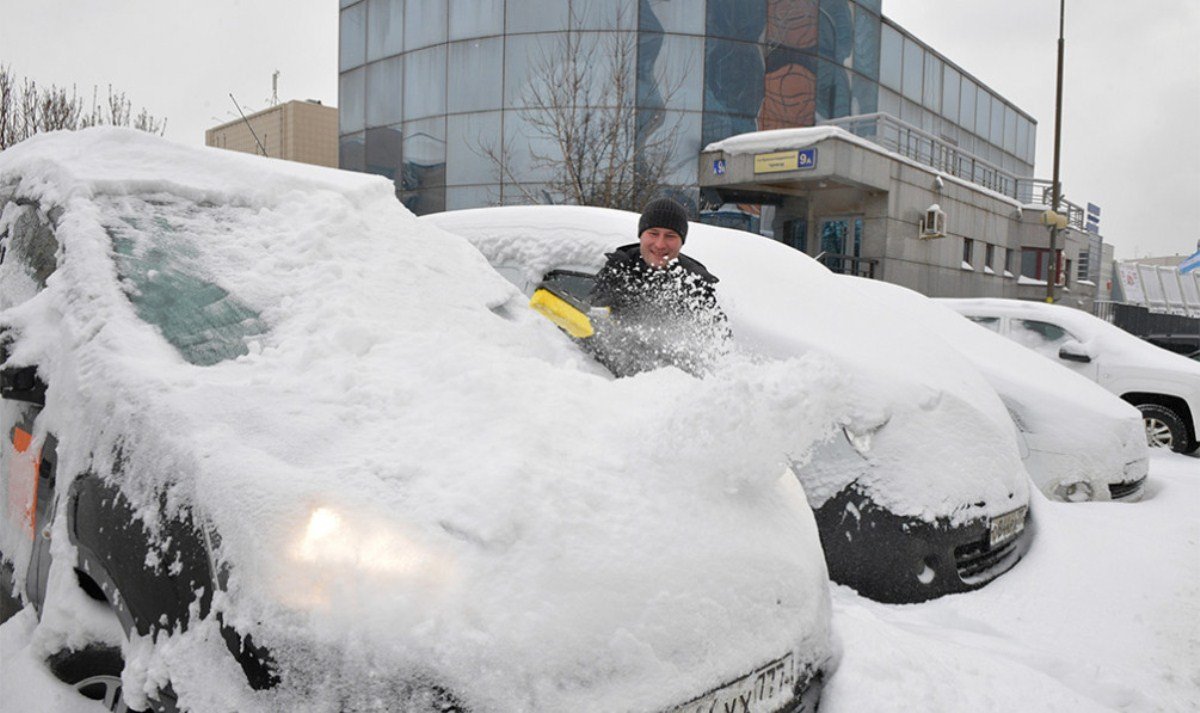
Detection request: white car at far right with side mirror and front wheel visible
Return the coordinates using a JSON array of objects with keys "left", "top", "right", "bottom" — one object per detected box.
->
[{"left": 941, "top": 299, "right": 1200, "bottom": 453}]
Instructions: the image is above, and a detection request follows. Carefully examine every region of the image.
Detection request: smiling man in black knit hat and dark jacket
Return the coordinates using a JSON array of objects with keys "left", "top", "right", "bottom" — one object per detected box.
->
[{"left": 589, "top": 198, "right": 730, "bottom": 376}]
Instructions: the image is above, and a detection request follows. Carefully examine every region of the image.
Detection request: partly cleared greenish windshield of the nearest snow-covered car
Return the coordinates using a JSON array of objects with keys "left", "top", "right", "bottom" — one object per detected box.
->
[{"left": 106, "top": 197, "right": 266, "bottom": 366}]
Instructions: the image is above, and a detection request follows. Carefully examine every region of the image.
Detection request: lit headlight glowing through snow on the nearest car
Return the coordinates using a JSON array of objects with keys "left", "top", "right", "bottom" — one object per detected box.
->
[{"left": 280, "top": 507, "right": 454, "bottom": 609}]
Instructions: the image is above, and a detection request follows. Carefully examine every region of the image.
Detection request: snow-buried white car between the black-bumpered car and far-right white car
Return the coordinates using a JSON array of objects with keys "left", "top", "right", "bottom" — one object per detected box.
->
[{"left": 844, "top": 277, "right": 1150, "bottom": 502}]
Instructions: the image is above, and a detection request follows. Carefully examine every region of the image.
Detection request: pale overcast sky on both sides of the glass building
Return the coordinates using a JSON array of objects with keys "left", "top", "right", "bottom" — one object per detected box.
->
[{"left": 0, "top": 0, "right": 1200, "bottom": 258}]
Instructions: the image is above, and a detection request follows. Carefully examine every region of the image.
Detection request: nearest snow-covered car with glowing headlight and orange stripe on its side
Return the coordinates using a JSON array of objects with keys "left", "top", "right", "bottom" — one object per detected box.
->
[{"left": 0, "top": 128, "right": 833, "bottom": 712}]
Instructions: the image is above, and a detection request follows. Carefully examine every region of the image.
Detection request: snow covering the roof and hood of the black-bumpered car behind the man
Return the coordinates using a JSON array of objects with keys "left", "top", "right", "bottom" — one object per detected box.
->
[{"left": 421, "top": 201, "right": 1028, "bottom": 523}]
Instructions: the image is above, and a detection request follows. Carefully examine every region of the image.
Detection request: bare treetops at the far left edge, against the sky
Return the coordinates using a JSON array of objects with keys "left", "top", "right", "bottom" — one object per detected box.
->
[{"left": 0, "top": 65, "right": 167, "bottom": 151}]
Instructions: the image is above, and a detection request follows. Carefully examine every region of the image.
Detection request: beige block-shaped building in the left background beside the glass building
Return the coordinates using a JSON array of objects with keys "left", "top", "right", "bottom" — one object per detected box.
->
[{"left": 204, "top": 101, "right": 337, "bottom": 168}]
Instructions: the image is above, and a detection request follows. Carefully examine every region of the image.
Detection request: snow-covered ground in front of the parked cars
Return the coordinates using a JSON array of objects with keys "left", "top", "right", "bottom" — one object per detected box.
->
[{"left": 0, "top": 451, "right": 1200, "bottom": 713}]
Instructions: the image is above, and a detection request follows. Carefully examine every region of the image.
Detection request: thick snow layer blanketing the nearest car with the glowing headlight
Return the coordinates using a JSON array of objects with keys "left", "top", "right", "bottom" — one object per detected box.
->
[{"left": 0, "top": 128, "right": 840, "bottom": 711}]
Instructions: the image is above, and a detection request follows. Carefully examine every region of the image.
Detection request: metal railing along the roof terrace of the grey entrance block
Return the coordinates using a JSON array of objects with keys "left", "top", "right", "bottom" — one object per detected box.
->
[{"left": 821, "top": 112, "right": 1086, "bottom": 225}]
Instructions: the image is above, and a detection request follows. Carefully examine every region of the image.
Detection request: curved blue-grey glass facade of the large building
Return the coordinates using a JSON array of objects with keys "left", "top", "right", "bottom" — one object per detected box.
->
[{"left": 338, "top": 0, "right": 1036, "bottom": 215}]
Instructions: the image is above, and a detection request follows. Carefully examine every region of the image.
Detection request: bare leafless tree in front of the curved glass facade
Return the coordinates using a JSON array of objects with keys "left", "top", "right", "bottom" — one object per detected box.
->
[{"left": 480, "top": 10, "right": 686, "bottom": 211}]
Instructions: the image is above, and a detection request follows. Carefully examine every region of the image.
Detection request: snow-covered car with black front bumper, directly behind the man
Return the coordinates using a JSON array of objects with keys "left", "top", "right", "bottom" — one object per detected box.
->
[{"left": 420, "top": 206, "right": 1030, "bottom": 603}]
